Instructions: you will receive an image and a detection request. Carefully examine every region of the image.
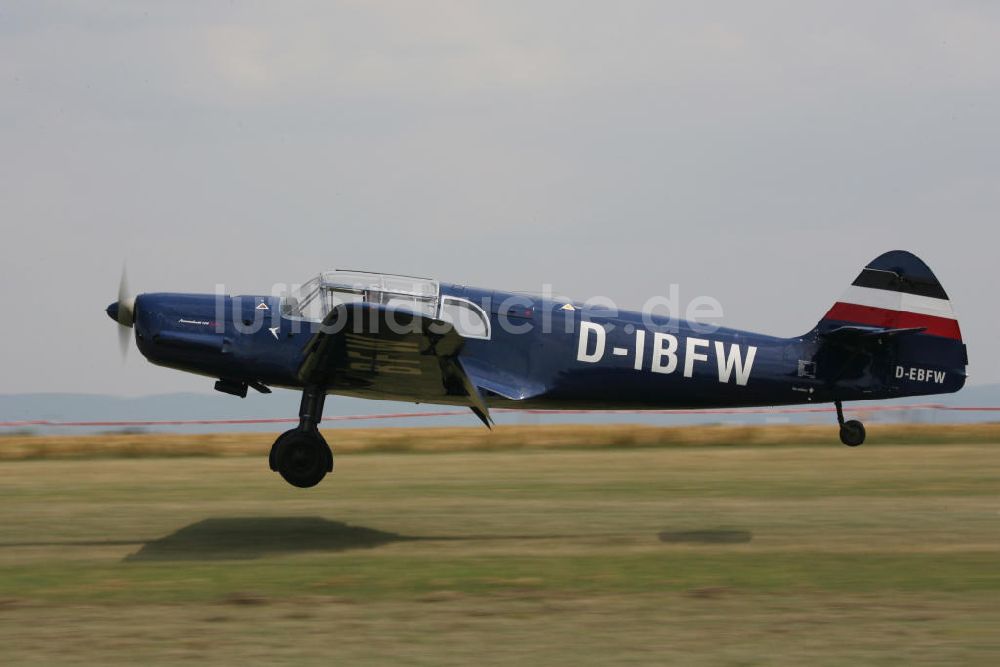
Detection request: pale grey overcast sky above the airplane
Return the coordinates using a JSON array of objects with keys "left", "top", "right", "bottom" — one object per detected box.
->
[{"left": 0, "top": 0, "right": 1000, "bottom": 395}]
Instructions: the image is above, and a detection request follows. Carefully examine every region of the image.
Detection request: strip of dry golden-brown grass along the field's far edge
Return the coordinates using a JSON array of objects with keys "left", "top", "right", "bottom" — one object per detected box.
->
[{"left": 0, "top": 423, "right": 1000, "bottom": 461}]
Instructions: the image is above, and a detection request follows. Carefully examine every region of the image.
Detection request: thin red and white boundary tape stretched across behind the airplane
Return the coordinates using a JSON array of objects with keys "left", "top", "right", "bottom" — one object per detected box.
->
[{"left": 0, "top": 403, "right": 1000, "bottom": 428}]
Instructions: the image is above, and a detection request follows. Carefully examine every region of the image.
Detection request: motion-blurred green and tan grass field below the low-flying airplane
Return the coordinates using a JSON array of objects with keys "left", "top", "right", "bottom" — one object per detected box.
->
[{"left": 0, "top": 427, "right": 1000, "bottom": 665}]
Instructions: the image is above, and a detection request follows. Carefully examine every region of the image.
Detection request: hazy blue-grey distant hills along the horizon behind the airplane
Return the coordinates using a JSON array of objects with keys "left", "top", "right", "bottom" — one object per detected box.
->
[{"left": 0, "top": 384, "right": 1000, "bottom": 435}]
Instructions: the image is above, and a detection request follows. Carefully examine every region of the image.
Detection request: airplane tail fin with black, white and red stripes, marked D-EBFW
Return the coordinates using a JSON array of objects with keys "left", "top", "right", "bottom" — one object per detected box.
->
[{"left": 813, "top": 250, "right": 968, "bottom": 398}]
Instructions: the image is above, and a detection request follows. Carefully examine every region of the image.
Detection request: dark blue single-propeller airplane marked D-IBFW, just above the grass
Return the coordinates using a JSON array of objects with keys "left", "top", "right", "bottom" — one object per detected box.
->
[{"left": 106, "top": 250, "right": 968, "bottom": 488}]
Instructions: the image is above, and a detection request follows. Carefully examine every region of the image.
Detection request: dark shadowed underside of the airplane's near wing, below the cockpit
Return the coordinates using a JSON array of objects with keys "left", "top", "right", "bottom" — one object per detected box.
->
[{"left": 298, "top": 303, "right": 493, "bottom": 427}]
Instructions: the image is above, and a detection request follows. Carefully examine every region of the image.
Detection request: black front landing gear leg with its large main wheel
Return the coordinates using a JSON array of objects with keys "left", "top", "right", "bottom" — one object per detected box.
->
[{"left": 269, "top": 387, "right": 333, "bottom": 489}]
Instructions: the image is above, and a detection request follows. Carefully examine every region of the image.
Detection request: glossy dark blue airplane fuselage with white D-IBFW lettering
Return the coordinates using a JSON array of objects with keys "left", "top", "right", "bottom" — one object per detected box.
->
[{"left": 129, "top": 283, "right": 965, "bottom": 409}]
